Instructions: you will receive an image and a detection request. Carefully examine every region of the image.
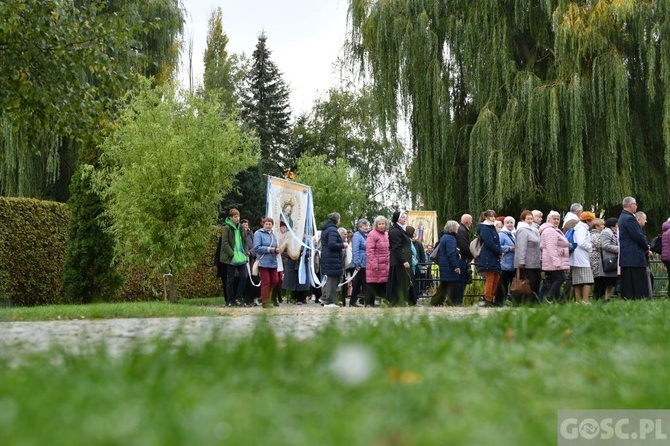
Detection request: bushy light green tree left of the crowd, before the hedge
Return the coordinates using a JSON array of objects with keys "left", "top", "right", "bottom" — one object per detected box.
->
[{"left": 97, "top": 81, "right": 254, "bottom": 274}]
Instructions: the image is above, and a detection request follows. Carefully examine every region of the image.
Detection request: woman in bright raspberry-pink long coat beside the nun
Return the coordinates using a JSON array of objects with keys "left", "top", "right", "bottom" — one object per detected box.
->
[{"left": 365, "top": 216, "right": 390, "bottom": 307}]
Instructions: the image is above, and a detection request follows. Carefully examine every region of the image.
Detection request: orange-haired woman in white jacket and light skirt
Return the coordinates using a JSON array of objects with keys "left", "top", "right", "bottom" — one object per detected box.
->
[{"left": 570, "top": 212, "right": 596, "bottom": 305}]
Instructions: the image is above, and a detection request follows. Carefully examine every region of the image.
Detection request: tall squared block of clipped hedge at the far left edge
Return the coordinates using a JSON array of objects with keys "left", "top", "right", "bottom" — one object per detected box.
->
[{"left": 0, "top": 197, "right": 69, "bottom": 305}]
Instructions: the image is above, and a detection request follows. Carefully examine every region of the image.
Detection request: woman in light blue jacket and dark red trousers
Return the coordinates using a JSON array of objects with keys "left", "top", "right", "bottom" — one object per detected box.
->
[{"left": 254, "top": 217, "right": 279, "bottom": 308}]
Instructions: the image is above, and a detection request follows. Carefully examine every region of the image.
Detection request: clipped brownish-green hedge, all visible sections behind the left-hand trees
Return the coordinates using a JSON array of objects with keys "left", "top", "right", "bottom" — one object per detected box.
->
[{"left": 0, "top": 197, "right": 221, "bottom": 306}]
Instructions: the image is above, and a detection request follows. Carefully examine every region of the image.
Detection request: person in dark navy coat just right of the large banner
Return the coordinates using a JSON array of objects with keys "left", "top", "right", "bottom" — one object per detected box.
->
[{"left": 321, "top": 212, "right": 349, "bottom": 308}]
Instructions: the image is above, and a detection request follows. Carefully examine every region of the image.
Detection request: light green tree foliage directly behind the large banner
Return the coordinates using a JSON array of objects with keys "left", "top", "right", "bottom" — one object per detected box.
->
[{"left": 295, "top": 155, "right": 368, "bottom": 227}]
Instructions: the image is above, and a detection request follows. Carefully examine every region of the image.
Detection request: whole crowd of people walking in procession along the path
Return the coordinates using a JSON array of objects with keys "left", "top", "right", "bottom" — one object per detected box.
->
[{"left": 215, "top": 197, "right": 670, "bottom": 308}]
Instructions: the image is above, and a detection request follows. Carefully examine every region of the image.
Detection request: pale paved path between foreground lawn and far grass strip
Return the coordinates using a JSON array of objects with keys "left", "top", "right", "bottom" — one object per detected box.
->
[{"left": 0, "top": 303, "right": 496, "bottom": 361}]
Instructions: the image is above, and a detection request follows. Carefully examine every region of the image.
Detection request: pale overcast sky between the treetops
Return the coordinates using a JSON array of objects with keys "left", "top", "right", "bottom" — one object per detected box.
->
[{"left": 180, "top": 0, "right": 348, "bottom": 116}]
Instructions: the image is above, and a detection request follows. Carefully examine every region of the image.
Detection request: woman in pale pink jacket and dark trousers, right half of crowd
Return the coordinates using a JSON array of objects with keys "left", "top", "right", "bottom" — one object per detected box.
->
[{"left": 540, "top": 211, "right": 570, "bottom": 302}]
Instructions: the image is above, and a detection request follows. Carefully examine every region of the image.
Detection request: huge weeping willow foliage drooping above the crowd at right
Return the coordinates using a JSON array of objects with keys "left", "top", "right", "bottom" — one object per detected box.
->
[{"left": 349, "top": 0, "right": 670, "bottom": 217}]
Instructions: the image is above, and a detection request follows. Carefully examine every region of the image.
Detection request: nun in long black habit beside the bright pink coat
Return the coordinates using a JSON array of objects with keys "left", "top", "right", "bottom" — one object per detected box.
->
[{"left": 386, "top": 211, "right": 414, "bottom": 306}]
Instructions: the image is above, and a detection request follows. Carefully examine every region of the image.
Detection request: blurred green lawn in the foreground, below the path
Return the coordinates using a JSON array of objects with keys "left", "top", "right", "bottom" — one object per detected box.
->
[{"left": 0, "top": 301, "right": 670, "bottom": 446}]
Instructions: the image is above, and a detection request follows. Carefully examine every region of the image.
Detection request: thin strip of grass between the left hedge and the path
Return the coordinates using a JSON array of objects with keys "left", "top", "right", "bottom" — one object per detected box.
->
[{"left": 0, "top": 298, "right": 222, "bottom": 321}]
